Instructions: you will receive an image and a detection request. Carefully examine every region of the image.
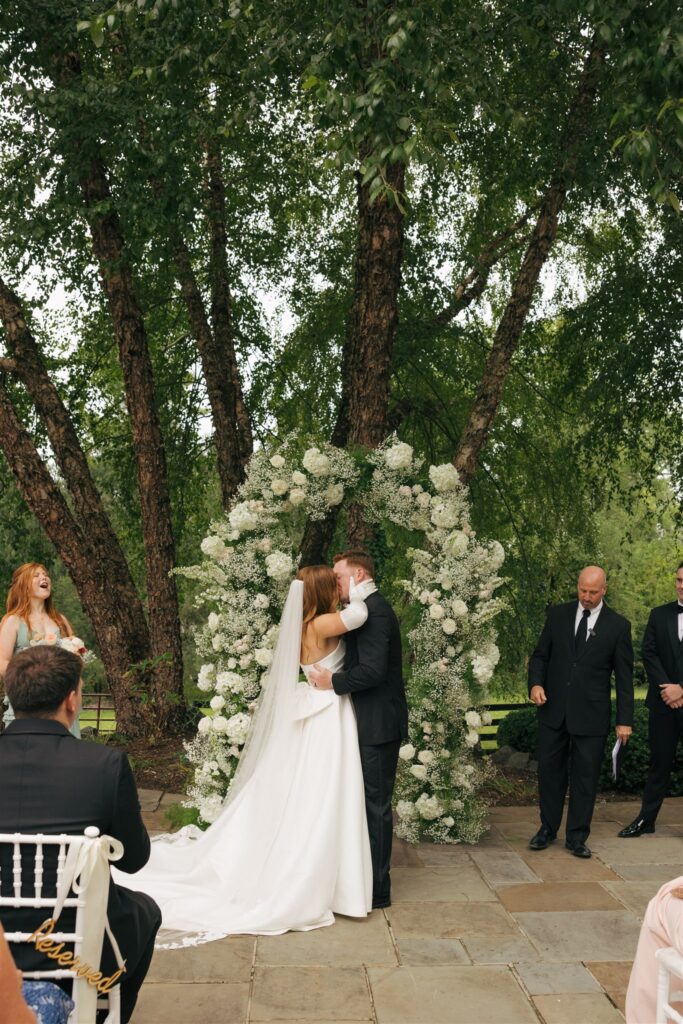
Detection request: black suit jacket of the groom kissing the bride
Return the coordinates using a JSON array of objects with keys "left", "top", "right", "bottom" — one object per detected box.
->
[{"left": 332, "top": 591, "right": 408, "bottom": 746}]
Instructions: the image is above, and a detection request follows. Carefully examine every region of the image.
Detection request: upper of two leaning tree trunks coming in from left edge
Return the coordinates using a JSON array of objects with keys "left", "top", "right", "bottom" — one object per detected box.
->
[{"left": 0, "top": 278, "right": 151, "bottom": 665}]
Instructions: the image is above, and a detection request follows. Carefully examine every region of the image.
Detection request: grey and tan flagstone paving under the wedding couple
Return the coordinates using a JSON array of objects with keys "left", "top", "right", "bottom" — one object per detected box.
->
[{"left": 132, "top": 790, "right": 683, "bottom": 1024}]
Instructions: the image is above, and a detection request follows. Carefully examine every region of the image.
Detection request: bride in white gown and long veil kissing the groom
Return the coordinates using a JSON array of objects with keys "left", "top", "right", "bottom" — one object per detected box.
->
[{"left": 113, "top": 565, "right": 373, "bottom": 947}]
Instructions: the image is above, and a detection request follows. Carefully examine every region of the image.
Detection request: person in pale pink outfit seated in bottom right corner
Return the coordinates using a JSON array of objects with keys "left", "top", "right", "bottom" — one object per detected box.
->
[{"left": 626, "top": 877, "right": 683, "bottom": 1024}]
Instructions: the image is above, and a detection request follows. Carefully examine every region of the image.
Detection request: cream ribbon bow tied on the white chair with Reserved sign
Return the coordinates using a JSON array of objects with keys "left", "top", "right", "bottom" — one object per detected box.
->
[{"left": 52, "top": 836, "right": 125, "bottom": 969}]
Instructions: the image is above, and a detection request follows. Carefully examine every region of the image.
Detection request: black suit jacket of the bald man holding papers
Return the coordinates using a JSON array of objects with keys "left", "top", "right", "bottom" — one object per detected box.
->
[{"left": 528, "top": 601, "right": 633, "bottom": 736}]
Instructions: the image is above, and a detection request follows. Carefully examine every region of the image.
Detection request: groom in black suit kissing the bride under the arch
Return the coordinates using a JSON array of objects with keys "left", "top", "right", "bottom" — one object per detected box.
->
[{"left": 310, "top": 551, "right": 408, "bottom": 907}]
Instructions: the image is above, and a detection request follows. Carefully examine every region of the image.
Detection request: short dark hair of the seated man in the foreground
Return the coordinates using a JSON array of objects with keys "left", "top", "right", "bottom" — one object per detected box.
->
[{"left": 4, "top": 644, "right": 83, "bottom": 718}]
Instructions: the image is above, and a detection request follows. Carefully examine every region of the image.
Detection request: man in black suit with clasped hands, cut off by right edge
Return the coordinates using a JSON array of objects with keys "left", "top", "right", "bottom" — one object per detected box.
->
[{"left": 618, "top": 562, "right": 683, "bottom": 839}]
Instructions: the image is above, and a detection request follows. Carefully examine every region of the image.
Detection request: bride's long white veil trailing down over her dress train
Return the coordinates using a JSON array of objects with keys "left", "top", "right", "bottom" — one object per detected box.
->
[{"left": 113, "top": 580, "right": 303, "bottom": 948}]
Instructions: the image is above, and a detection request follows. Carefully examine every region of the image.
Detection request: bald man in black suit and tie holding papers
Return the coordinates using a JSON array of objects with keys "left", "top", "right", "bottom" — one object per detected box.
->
[{"left": 528, "top": 565, "right": 633, "bottom": 857}]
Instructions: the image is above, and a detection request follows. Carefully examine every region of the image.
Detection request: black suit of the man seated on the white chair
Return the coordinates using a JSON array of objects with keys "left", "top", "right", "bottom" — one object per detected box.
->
[{"left": 0, "top": 718, "right": 160, "bottom": 977}]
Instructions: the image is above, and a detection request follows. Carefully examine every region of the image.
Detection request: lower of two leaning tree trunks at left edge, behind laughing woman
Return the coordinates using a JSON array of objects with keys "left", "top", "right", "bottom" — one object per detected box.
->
[{"left": 0, "top": 381, "right": 147, "bottom": 736}]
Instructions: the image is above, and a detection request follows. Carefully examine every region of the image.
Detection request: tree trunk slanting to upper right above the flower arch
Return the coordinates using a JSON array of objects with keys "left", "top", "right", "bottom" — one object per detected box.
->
[{"left": 453, "top": 43, "right": 605, "bottom": 483}]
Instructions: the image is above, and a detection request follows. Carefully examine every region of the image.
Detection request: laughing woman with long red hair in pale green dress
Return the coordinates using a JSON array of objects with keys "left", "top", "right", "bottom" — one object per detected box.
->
[{"left": 0, "top": 562, "right": 81, "bottom": 738}]
